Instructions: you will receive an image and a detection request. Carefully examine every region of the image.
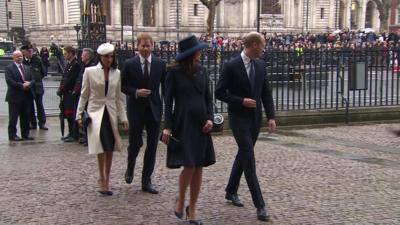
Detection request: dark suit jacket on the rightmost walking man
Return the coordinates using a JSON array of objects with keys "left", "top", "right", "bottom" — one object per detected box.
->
[{"left": 215, "top": 55, "right": 275, "bottom": 128}]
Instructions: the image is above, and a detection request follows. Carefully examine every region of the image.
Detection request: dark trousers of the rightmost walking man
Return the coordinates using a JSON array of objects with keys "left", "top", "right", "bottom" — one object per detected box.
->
[{"left": 225, "top": 116, "right": 265, "bottom": 208}]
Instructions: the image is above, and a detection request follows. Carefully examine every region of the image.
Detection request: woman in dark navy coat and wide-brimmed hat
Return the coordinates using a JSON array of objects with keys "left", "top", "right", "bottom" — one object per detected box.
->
[{"left": 162, "top": 35, "right": 215, "bottom": 224}]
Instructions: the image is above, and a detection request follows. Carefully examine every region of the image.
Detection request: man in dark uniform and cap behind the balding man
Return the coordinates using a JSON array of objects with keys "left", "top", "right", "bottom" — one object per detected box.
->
[{"left": 21, "top": 45, "right": 48, "bottom": 130}]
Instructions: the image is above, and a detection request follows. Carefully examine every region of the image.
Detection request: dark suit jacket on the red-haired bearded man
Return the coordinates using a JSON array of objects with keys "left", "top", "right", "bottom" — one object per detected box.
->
[{"left": 121, "top": 55, "right": 166, "bottom": 121}]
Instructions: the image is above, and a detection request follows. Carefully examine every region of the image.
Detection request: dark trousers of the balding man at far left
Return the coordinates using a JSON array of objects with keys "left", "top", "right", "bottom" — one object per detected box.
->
[{"left": 8, "top": 100, "right": 31, "bottom": 139}]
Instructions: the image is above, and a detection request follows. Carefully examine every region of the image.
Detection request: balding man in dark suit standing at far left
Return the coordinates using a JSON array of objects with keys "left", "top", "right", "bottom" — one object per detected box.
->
[{"left": 5, "top": 51, "right": 34, "bottom": 141}]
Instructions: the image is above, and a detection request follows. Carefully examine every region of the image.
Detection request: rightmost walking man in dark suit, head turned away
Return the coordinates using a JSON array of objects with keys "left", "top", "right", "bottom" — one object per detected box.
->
[{"left": 215, "top": 32, "right": 276, "bottom": 221}]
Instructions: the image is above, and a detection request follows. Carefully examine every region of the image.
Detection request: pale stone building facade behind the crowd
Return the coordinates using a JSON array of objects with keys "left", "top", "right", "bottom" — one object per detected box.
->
[{"left": 0, "top": 0, "right": 379, "bottom": 46}]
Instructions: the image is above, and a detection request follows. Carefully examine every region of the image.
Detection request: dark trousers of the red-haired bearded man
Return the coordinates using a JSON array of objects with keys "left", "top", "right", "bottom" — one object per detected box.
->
[{"left": 127, "top": 106, "right": 160, "bottom": 185}]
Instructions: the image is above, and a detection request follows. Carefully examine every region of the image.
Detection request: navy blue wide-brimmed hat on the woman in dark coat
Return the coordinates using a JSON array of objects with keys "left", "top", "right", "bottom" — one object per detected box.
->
[{"left": 175, "top": 35, "right": 208, "bottom": 62}]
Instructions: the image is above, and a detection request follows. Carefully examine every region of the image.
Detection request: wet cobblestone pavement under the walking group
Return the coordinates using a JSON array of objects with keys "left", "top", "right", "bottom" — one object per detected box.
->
[{"left": 0, "top": 118, "right": 400, "bottom": 225}]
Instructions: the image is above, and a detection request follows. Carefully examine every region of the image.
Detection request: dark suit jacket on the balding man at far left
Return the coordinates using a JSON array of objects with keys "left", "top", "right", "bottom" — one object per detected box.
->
[{"left": 5, "top": 62, "right": 34, "bottom": 102}]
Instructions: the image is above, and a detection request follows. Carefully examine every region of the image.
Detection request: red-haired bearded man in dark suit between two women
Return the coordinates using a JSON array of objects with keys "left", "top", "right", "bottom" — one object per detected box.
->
[{"left": 121, "top": 33, "right": 166, "bottom": 194}]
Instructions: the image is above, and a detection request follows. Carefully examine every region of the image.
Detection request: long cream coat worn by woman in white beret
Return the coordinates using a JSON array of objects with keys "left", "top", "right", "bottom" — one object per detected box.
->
[{"left": 76, "top": 63, "right": 128, "bottom": 154}]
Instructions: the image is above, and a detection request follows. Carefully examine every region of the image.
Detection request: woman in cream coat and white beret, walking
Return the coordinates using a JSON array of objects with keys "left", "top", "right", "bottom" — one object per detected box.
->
[{"left": 76, "top": 43, "right": 128, "bottom": 195}]
